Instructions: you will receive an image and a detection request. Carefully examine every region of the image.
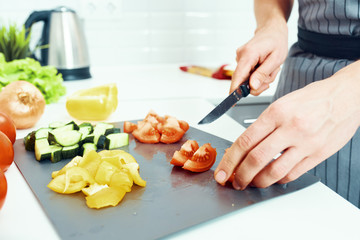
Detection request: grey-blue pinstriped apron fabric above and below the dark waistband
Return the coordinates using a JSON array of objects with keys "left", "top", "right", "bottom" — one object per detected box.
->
[{"left": 274, "top": 0, "right": 360, "bottom": 208}]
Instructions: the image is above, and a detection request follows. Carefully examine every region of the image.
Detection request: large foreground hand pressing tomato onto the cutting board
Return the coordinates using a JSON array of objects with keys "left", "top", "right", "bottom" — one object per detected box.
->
[{"left": 214, "top": 64, "right": 360, "bottom": 189}]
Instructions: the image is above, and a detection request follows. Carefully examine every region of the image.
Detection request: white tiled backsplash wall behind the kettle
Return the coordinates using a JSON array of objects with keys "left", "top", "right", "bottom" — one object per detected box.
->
[{"left": 0, "top": 0, "right": 297, "bottom": 66}]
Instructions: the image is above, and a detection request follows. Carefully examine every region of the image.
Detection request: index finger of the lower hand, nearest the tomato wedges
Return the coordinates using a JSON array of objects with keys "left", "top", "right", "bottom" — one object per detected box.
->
[{"left": 214, "top": 111, "right": 275, "bottom": 184}]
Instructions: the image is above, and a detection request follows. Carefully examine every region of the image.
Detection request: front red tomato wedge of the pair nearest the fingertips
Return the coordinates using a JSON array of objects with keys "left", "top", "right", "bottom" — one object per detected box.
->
[{"left": 183, "top": 143, "right": 217, "bottom": 172}]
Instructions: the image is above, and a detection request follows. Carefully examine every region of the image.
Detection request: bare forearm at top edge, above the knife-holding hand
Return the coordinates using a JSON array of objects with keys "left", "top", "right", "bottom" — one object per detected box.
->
[{"left": 254, "top": 0, "right": 294, "bottom": 29}]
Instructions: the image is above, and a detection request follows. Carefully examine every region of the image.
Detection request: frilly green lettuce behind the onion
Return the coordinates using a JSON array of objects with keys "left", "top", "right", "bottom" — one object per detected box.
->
[{"left": 0, "top": 52, "right": 66, "bottom": 104}]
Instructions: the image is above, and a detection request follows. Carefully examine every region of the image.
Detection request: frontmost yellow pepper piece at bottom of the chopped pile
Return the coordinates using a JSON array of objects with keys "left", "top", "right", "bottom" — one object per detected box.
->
[{"left": 86, "top": 187, "right": 126, "bottom": 209}]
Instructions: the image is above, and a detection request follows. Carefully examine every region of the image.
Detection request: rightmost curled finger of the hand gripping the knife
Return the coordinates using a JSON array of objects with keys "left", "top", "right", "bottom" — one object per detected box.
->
[{"left": 250, "top": 54, "right": 280, "bottom": 90}]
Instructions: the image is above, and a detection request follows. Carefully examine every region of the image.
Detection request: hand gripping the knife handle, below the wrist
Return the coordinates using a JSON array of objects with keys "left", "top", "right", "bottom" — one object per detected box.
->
[{"left": 230, "top": 18, "right": 288, "bottom": 96}]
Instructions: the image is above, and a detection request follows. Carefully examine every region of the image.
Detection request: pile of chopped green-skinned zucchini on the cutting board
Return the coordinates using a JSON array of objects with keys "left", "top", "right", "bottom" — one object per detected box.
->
[{"left": 24, "top": 121, "right": 129, "bottom": 162}]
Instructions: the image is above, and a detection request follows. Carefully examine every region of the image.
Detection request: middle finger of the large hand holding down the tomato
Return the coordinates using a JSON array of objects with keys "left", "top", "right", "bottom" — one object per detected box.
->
[{"left": 234, "top": 125, "right": 291, "bottom": 189}]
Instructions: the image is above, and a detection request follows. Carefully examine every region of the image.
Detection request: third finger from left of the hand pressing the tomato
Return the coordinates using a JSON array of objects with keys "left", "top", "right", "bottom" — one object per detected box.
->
[{"left": 252, "top": 147, "right": 303, "bottom": 188}]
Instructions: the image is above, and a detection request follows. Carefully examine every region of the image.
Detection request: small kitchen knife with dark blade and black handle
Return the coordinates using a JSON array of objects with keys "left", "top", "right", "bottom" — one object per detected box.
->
[{"left": 198, "top": 80, "right": 250, "bottom": 124}]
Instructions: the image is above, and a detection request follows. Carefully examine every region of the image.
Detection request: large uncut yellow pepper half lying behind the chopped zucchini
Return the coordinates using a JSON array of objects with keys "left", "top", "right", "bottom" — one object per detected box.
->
[{"left": 66, "top": 83, "right": 118, "bottom": 121}]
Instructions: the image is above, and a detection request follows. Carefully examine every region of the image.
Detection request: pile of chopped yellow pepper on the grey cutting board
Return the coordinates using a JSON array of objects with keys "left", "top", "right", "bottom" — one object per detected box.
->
[{"left": 47, "top": 150, "right": 146, "bottom": 209}]
